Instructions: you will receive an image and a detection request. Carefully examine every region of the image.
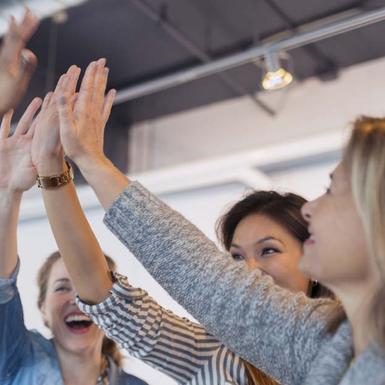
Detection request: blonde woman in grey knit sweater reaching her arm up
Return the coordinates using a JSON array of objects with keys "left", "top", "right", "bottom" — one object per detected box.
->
[{"left": 47, "top": 58, "right": 385, "bottom": 385}]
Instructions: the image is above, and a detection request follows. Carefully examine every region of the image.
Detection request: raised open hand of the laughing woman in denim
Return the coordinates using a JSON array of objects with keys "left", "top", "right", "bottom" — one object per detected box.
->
[{"left": 0, "top": 98, "right": 41, "bottom": 192}]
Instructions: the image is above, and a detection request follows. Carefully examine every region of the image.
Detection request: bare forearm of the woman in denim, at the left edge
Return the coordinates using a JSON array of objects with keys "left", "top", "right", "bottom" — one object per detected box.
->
[{"left": 0, "top": 190, "right": 22, "bottom": 278}]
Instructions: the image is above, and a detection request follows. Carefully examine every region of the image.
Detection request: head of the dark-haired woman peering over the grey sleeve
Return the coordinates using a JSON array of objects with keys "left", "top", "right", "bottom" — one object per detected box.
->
[{"left": 217, "top": 191, "right": 333, "bottom": 298}]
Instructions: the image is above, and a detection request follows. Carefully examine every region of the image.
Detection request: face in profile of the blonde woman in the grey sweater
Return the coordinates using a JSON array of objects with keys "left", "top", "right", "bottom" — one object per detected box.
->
[{"left": 300, "top": 164, "right": 372, "bottom": 290}]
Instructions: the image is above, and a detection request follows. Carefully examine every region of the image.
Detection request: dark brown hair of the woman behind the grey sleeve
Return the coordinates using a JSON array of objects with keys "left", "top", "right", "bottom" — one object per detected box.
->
[{"left": 216, "top": 191, "right": 333, "bottom": 385}]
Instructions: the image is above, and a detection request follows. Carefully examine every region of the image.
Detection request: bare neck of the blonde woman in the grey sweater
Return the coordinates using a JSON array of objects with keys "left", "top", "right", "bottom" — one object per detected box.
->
[{"left": 333, "top": 283, "right": 375, "bottom": 357}]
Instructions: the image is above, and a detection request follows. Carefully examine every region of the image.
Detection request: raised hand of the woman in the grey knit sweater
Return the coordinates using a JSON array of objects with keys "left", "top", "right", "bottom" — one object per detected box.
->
[{"left": 59, "top": 59, "right": 116, "bottom": 166}]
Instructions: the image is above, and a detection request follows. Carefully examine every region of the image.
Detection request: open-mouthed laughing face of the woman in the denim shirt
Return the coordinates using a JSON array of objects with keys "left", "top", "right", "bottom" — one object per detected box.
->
[{"left": 41, "top": 258, "right": 104, "bottom": 354}]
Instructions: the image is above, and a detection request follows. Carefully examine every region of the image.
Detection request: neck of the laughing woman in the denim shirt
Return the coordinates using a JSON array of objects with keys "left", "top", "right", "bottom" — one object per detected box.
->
[{"left": 55, "top": 345, "right": 104, "bottom": 385}]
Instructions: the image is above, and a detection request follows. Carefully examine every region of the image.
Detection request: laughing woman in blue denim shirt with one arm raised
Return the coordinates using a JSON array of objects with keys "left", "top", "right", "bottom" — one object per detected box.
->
[{"left": 0, "top": 98, "right": 145, "bottom": 385}]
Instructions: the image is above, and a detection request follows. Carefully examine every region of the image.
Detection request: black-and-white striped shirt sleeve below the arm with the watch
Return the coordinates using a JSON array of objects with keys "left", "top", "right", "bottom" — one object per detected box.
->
[{"left": 77, "top": 274, "right": 248, "bottom": 385}]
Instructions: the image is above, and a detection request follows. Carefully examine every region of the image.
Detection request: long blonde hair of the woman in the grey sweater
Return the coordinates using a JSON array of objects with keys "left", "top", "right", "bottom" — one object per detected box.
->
[{"left": 343, "top": 116, "right": 385, "bottom": 348}]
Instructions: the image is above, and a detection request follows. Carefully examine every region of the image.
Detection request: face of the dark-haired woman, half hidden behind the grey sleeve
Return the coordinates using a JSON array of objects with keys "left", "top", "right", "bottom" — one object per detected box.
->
[{"left": 229, "top": 214, "right": 309, "bottom": 292}]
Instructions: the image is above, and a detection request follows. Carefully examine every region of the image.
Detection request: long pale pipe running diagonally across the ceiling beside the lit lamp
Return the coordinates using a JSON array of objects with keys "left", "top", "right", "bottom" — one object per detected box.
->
[{"left": 115, "top": 7, "right": 385, "bottom": 104}]
